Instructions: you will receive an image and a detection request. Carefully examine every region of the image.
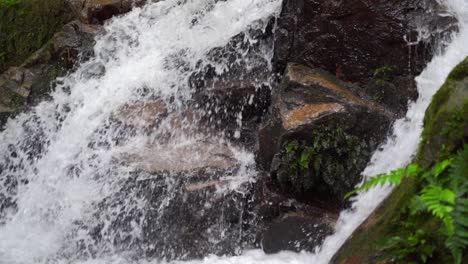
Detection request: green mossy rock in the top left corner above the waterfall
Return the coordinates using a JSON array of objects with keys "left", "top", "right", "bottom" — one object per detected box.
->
[{"left": 0, "top": 0, "right": 73, "bottom": 72}]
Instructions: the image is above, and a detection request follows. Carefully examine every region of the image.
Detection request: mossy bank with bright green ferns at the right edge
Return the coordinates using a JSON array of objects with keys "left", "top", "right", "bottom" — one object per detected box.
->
[{"left": 334, "top": 58, "right": 468, "bottom": 263}]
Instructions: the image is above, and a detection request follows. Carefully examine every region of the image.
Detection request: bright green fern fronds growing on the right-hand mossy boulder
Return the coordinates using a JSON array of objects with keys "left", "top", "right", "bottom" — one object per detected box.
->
[{"left": 347, "top": 145, "right": 468, "bottom": 264}]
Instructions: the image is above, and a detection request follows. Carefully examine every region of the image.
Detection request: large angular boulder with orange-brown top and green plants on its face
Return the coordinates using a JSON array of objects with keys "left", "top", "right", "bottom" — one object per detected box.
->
[{"left": 258, "top": 63, "right": 393, "bottom": 207}]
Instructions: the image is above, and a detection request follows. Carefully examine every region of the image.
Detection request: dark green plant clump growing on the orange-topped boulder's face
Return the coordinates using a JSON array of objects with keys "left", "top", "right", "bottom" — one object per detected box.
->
[{"left": 277, "top": 125, "right": 370, "bottom": 200}]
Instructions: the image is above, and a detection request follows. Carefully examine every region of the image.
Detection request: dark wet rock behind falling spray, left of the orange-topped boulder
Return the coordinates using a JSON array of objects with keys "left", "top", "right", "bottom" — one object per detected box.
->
[{"left": 190, "top": 27, "right": 274, "bottom": 147}]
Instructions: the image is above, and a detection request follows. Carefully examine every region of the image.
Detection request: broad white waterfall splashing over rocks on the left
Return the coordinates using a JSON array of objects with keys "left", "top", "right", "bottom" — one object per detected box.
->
[{"left": 0, "top": 0, "right": 281, "bottom": 264}]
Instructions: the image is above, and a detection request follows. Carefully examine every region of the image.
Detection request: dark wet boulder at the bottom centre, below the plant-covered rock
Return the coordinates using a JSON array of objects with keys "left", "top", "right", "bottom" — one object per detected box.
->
[{"left": 254, "top": 177, "right": 339, "bottom": 253}]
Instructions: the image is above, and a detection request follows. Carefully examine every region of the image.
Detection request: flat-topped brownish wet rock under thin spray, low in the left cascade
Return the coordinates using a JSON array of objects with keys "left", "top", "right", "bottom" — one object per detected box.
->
[{"left": 83, "top": 142, "right": 260, "bottom": 260}]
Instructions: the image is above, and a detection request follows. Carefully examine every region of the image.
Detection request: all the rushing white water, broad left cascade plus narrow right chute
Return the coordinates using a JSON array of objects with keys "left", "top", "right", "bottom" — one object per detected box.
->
[{"left": 0, "top": 0, "right": 468, "bottom": 264}]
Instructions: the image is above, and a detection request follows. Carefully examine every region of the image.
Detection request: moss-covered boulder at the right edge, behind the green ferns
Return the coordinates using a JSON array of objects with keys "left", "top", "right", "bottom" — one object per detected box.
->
[{"left": 332, "top": 58, "right": 468, "bottom": 264}]
